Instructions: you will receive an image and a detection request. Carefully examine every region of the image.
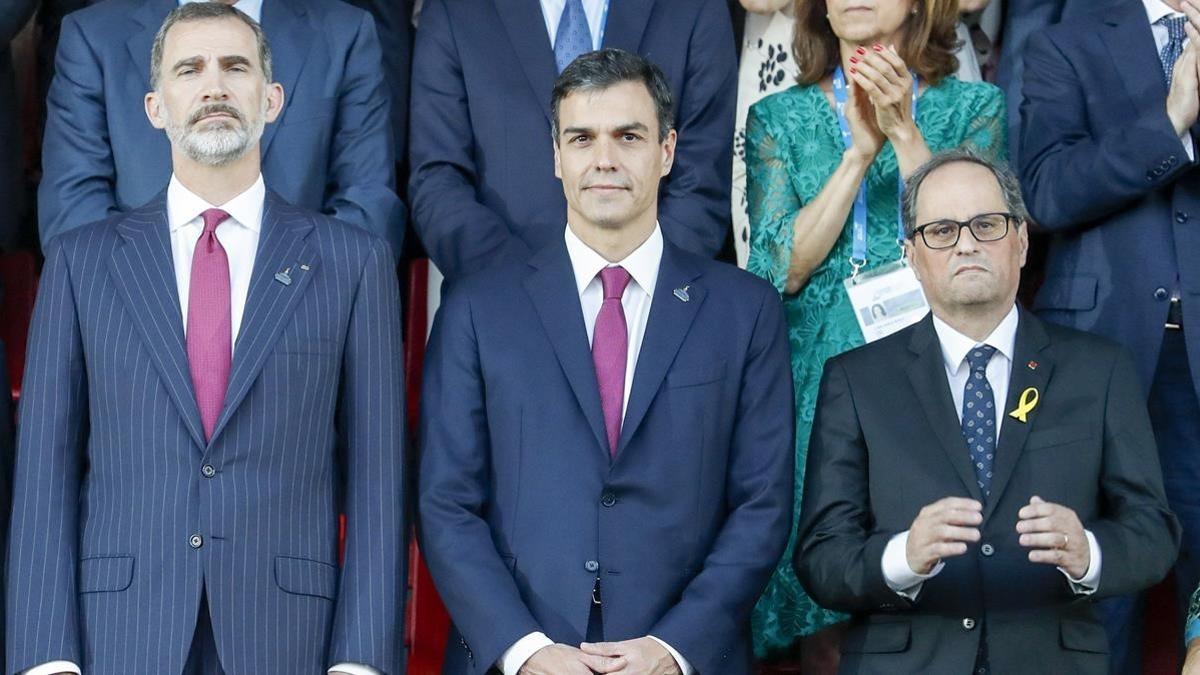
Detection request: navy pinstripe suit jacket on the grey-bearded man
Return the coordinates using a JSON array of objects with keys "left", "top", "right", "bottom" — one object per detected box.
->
[{"left": 7, "top": 187, "right": 404, "bottom": 675}]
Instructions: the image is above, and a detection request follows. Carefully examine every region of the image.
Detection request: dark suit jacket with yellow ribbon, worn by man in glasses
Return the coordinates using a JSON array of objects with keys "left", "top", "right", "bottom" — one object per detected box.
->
[{"left": 796, "top": 310, "right": 1180, "bottom": 675}]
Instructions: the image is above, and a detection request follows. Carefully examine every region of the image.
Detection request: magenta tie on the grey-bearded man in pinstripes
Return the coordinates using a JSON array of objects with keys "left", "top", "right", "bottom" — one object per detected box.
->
[{"left": 187, "top": 209, "right": 233, "bottom": 441}]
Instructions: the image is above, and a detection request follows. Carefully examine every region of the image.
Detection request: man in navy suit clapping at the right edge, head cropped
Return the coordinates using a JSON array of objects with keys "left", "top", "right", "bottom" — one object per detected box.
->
[{"left": 1020, "top": 0, "right": 1200, "bottom": 673}]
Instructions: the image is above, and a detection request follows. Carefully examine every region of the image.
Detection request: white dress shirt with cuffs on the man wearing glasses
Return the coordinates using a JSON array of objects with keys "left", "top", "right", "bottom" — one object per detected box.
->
[{"left": 882, "top": 305, "right": 1100, "bottom": 601}]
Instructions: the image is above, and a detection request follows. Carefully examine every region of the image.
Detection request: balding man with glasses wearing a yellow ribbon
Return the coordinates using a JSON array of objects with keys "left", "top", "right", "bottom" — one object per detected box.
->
[{"left": 796, "top": 150, "right": 1180, "bottom": 674}]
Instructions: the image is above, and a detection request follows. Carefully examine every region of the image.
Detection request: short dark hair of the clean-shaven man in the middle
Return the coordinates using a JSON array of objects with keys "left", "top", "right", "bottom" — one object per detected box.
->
[{"left": 550, "top": 47, "right": 674, "bottom": 143}]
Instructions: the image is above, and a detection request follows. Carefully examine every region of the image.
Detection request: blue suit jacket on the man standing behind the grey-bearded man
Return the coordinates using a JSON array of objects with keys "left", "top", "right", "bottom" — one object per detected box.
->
[{"left": 38, "top": 0, "right": 404, "bottom": 253}]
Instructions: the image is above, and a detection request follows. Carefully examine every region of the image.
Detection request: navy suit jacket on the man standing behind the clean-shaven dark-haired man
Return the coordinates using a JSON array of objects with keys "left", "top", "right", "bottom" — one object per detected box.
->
[{"left": 409, "top": 0, "right": 737, "bottom": 282}]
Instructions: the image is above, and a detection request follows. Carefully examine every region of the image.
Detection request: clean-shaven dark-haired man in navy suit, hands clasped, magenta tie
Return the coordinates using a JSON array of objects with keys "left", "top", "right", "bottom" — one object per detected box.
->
[{"left": 419, "top": 48, "right": 793, "bottom": 675}]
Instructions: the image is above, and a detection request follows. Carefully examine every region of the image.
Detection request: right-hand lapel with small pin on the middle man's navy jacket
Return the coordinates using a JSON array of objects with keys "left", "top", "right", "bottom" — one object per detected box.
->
[{"left": 617, "top": 241, "right": 707, "bottom": 459}]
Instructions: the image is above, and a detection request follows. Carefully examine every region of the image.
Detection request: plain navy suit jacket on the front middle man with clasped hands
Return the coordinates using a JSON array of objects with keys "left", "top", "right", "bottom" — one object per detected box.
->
[{"left": 419, "top": 237, "right": 794, "bottom": 675}]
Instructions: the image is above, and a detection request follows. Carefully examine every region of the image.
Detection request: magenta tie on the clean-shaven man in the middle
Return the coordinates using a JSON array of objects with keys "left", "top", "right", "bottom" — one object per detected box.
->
[{"left": 592, "top": 267, "right": 630, "bottom": 456}]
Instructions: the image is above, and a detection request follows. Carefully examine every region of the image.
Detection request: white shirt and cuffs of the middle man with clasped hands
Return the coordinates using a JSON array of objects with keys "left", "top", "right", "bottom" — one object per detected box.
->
[{"left": 497, "top": 224, "right": 694, "bottom": 675}]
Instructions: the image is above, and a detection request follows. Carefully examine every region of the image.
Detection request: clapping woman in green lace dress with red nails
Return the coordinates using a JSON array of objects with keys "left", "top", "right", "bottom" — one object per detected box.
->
[{"left": 746, "top": 0, "right": 1006, "bottom": 673}]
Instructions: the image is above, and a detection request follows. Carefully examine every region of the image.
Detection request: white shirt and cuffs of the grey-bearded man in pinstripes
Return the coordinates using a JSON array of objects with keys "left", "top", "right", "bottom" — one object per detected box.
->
[{"left": 22, "top": 172, "right": 380, "bottom": 675}]
